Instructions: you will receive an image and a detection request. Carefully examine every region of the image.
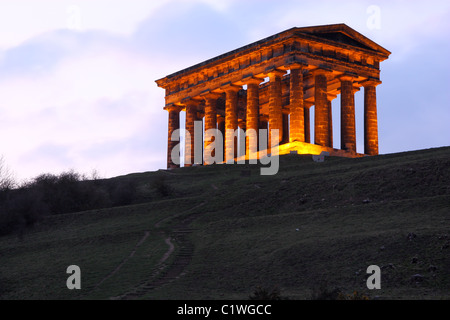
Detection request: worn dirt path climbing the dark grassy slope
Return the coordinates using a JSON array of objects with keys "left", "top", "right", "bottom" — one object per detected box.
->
[{"left": 109, "top": 202, "right": 205, "bottom": 300}]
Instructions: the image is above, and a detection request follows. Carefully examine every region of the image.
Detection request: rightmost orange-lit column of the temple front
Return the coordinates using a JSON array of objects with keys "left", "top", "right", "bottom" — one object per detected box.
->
[{"left": 363, "top": 80, "right": 381, "bottom": 156}]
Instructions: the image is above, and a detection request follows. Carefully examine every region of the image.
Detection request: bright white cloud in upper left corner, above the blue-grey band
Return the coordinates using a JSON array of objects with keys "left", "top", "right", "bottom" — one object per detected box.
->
[{"left": 0, "top": 0, "right": 169, "bottom": 48}]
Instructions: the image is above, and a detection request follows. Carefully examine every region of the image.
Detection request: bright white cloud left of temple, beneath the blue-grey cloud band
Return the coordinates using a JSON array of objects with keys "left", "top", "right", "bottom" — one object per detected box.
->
[{"left": 0, "top": 28, "right": 167, "bottom": 179}]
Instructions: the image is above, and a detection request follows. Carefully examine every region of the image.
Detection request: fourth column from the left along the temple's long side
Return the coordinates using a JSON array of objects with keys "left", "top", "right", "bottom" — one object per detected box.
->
[{"left": 224, "top": 85, "right": 241, "bottom": 161}]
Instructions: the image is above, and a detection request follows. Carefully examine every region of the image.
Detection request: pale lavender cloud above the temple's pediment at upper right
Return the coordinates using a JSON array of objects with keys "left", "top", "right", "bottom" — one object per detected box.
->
[{"left": 232, "top": 0, "right": 450, "bottom": 60}]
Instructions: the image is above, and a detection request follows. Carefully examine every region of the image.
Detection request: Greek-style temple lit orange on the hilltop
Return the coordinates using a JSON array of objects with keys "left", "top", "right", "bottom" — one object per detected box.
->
[{"left": 156, "top": 24, "right": 390, "bottom": 168}]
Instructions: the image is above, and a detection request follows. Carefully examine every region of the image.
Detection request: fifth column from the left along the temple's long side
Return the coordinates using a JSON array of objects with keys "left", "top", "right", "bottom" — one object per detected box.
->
[{"left": 245, "top": 78, "right": 261, "bottom": 155}]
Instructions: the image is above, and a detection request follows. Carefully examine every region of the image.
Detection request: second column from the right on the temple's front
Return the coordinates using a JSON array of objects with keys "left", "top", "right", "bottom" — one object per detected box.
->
[{"left": 339, "top": 76, "right": 356, "bottom": 152}]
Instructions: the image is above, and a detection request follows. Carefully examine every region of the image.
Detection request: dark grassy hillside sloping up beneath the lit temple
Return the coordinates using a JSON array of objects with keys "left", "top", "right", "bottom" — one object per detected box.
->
[{"left": 0, "top": 147, "right": 450, "bottom": 299}]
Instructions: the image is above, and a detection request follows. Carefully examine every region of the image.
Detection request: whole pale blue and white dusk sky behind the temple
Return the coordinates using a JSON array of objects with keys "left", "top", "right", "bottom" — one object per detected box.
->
[{"left": 0, "top": 0, "right": 450, "bottom": 180}]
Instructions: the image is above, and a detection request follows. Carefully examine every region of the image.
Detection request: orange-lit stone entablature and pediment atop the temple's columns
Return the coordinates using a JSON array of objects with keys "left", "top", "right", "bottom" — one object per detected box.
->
[{"left": 156, "top": 25, "right": 389, "bottom": 105}]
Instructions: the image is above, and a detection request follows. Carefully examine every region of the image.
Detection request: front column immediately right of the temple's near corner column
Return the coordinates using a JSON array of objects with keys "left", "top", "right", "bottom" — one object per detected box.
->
[{"left": 314, "top": 70, "right": 329, "bottom": 147}]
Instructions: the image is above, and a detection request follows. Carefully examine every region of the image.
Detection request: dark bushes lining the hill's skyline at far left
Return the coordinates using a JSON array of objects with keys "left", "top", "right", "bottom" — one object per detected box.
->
[{"left": 0, "top": 171, "right": 143, "bottom": 235}]
